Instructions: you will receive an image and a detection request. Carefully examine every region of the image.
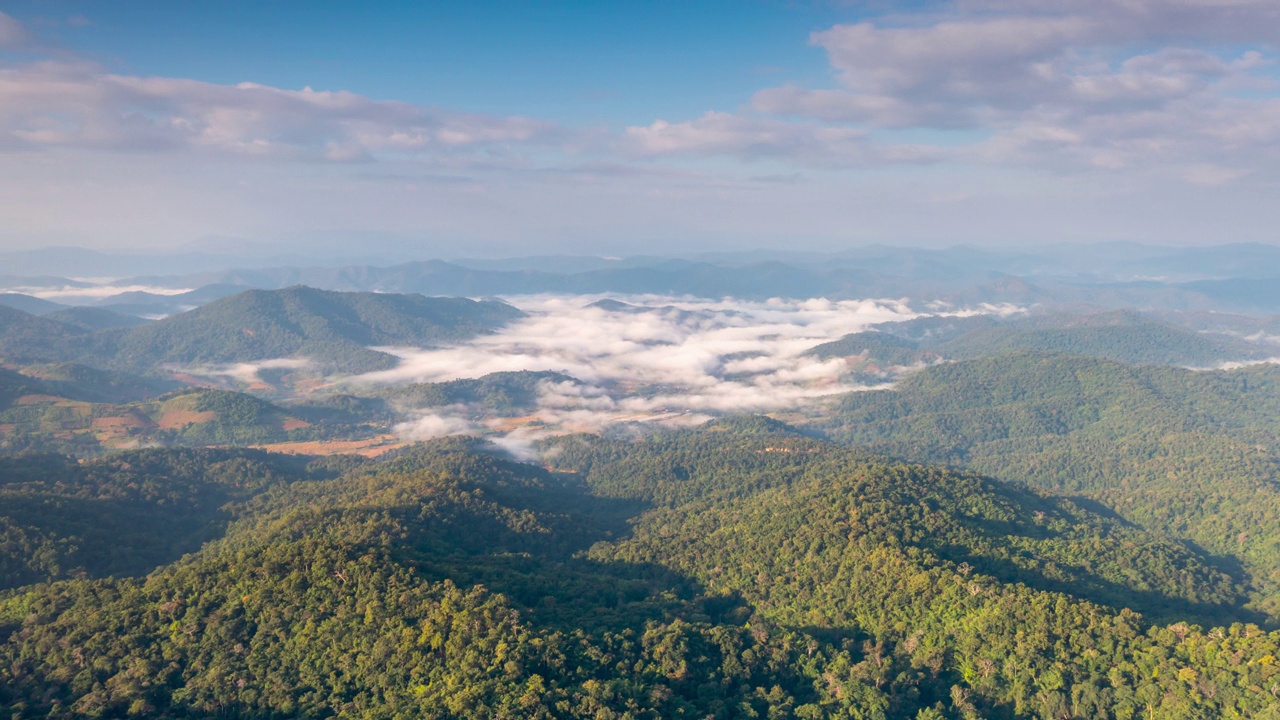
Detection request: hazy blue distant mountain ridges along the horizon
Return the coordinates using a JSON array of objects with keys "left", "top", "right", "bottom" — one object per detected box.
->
[{"left": 12, "top": 242, "right": 1280, "bottom": 312}]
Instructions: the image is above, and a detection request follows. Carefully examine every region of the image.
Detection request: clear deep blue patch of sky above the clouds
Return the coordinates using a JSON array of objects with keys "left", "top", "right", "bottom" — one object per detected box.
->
[{"left": 13, "top": 0, "right": 855, "bottom": 123}]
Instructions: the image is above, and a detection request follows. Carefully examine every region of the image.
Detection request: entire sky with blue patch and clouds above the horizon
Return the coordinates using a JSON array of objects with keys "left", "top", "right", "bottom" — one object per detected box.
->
[{"left": 0, "top": 0, "right": 1280, "bottom": 258}]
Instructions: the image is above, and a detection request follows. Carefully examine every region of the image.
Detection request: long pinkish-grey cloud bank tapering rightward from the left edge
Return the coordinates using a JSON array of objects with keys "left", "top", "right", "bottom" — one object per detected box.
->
[{"left": 0, "top": 61, "right": 558, "bottom": 161}]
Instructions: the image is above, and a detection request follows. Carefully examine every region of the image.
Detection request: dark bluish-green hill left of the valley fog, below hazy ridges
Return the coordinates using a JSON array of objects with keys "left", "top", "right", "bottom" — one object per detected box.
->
[{"left": 0, "top": 287, "right": 522, "bottom": 373}]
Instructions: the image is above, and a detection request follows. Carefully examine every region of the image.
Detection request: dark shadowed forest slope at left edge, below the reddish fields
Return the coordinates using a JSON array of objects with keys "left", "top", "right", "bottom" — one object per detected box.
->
[{"left": 0, "top": 450, "right": 316, "bottom": 589}]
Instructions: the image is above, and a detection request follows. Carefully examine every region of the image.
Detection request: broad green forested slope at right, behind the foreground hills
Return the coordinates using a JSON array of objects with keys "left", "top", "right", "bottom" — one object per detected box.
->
[{"left": 822, "top": 354, "right": 1280, "bottom": 616}]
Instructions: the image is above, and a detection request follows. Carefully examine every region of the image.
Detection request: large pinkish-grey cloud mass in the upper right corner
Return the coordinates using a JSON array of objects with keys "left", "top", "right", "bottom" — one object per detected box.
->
[{"left": 751, "top": 0, "right": 1280, "bottom": 176}]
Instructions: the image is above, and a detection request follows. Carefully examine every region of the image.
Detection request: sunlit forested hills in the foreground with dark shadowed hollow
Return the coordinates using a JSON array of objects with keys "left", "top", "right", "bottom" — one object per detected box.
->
[{"left": 0, "top": 420, "right": 1280, "bottom": 720}]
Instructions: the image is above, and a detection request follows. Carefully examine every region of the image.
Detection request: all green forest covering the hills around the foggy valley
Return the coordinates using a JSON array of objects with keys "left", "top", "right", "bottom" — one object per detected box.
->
[{"left": 12, "top": 287, "right": 1280, "bottom": 720}]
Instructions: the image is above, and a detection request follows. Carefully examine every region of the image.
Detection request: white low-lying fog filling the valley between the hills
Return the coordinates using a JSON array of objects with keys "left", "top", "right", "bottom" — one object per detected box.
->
[{"left": 352, "top": 296, "right": 1012, "bottom": 454}]
